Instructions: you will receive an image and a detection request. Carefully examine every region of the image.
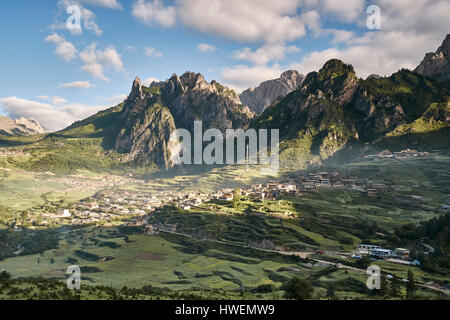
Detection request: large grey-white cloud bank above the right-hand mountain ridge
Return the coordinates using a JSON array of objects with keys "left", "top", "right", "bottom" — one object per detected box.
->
[{"left": 291, "top": 0, "right": 450, "bottom": 78}]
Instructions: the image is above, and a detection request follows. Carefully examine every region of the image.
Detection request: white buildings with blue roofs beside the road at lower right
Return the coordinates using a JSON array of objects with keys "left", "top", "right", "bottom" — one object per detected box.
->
[{"left": 352, "top": 244, "right": 420, "bottom": 265}]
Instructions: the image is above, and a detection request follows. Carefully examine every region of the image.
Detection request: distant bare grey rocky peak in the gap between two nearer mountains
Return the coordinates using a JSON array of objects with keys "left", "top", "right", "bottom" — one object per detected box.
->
[{"left": 239, "top": 70, "right": 305, "bottom": 115}]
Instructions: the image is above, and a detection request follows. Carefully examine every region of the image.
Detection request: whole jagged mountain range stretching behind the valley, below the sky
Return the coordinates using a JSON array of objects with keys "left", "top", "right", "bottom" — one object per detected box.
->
[{"left": 1, "top": 35, "right": 450, "bottom": 172}]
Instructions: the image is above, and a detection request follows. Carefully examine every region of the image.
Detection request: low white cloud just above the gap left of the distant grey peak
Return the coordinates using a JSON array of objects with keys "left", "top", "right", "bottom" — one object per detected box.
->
[{"left": 222, "top": 64, "right": 283, "bottom": 92}]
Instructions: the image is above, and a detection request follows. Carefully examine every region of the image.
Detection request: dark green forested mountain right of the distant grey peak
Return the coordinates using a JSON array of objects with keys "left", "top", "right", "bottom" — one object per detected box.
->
[{"left": 252, "top": 60, "right": 450, "bottom": 166}]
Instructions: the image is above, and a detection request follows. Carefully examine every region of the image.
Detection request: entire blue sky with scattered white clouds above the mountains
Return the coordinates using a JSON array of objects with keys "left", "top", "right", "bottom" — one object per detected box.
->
[{"left": 0, "top": 0, "right": 450, "bottom": 131}]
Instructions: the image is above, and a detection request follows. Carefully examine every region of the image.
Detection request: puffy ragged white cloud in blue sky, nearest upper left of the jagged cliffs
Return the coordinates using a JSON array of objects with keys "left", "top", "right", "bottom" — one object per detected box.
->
[{"left": 80, "top": 43, "right": 123, "bottom": 81}]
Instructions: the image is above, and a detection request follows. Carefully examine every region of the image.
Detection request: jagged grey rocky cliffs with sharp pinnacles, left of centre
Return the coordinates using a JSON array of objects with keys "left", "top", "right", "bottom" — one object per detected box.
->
[{"left": 115, "top": 72, "right": 254, "bottom": 168}]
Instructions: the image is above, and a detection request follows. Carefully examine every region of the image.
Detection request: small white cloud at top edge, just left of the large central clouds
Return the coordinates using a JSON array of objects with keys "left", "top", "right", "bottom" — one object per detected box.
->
[{"left": 132, "top": 0, "right": 176, "bottom": 27}]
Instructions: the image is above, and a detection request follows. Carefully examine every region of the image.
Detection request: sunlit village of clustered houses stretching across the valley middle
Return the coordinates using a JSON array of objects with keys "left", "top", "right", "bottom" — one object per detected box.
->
[{"left": 22, "top": 171, "right": 388, "bottom": 229}]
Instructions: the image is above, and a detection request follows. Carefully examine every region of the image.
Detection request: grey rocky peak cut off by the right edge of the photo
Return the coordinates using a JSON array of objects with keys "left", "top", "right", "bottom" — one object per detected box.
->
[{"left": 414, "top": 34, "right": 450, "bottom": 81}]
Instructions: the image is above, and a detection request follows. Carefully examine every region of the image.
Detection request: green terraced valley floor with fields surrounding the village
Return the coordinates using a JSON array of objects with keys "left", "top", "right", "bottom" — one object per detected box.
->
[{"left": 0, "top": 154, "right": 450, "bottom": 299}]
